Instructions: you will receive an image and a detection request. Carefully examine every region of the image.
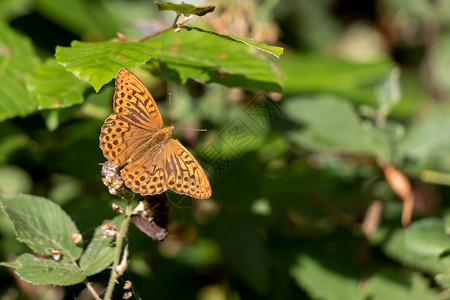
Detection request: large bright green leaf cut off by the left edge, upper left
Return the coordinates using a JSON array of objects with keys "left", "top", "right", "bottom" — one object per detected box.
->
[{"left": 0, "top": 21, "right": 39, "bottom": 121}]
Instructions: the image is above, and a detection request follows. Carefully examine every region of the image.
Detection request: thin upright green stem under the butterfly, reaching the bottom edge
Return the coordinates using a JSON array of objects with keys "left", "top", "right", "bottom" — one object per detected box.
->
[{"left": 104, "top": 193, "right": 133, "bottom": 300}]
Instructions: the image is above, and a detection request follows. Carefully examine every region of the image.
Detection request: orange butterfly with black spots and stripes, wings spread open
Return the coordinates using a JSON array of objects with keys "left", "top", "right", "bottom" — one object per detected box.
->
[{"left": 100, "top": 69, "right": 212, "bottom": 199}]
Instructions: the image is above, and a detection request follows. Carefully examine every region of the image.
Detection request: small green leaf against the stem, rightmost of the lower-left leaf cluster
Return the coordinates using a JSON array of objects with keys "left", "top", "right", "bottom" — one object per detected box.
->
[{"left": 80, "top": 215, "right": 123, "bottom": 276}]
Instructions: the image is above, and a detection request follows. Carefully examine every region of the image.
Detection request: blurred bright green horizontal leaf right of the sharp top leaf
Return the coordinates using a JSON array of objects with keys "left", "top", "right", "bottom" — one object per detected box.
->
[{"left": 280, "top": 53, "right": 393, "bottom": 104}]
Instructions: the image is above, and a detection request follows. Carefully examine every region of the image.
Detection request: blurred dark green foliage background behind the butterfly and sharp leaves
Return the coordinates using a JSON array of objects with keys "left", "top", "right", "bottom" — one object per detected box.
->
[{"left": 0, "top": 0, "right": 450, "bottom": 300}]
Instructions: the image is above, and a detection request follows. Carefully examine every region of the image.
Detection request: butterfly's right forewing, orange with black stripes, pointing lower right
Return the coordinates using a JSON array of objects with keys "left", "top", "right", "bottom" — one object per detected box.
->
[{"left": 164, "top": 139, "right": 211, "bottom": 199}]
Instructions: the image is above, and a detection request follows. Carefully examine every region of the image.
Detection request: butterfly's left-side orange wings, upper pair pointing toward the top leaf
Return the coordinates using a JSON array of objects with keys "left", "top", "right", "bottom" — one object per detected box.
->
[{"left": 100, "top": 69, "right": 163, "bottom": 166}]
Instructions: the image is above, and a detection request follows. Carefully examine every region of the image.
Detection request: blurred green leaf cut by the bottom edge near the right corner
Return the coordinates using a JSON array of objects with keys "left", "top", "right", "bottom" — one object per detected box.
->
[{"left": 366, "top": 268, "right": 436, "bottom": 300}]
